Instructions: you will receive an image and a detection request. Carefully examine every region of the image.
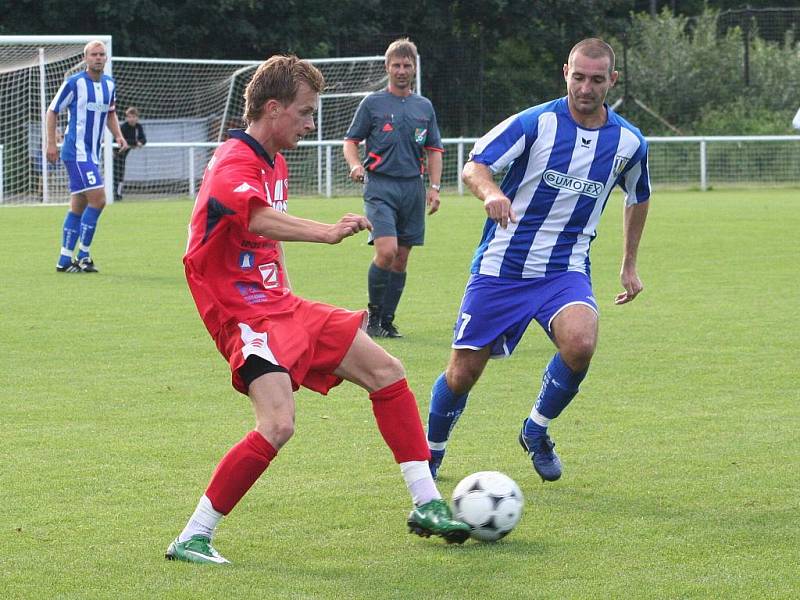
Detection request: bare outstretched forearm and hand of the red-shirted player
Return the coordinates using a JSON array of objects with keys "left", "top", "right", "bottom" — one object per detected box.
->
[{"left": 249, "top": 206, "right": 372, "bottom": 244}]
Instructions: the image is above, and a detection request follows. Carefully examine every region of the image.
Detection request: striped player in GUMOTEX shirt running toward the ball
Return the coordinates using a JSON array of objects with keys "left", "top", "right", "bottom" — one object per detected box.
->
[{"left": 427, "top": 38, "right": 650, "bottom": 481}]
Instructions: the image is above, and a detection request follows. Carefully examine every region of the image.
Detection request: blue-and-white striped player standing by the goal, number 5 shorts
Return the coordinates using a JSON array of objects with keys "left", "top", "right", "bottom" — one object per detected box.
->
[{"left": 47, "top": 40, "right": 128, "bottom": 273}]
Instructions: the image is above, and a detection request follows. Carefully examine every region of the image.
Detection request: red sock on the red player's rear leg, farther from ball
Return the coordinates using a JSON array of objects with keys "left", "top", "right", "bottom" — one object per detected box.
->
[{"left": 206, "top": 431, "right": 278, "bottom": 515}]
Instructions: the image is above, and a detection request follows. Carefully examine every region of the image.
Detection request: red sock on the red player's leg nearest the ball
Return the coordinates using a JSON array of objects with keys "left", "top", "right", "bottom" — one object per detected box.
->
[{"left": 369, "top": 378, "right": 431, "bottom": 463}]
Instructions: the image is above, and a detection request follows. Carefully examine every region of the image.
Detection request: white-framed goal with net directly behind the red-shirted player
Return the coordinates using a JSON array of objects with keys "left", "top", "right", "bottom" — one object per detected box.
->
[{"left": 114, "top": 56, "right": 386, "bottom": 198}]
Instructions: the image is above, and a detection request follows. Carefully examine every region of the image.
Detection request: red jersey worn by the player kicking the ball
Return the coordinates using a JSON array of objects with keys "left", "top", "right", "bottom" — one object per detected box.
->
[{"left": 183, "top": 130, "right": 296, "bottom": 335}]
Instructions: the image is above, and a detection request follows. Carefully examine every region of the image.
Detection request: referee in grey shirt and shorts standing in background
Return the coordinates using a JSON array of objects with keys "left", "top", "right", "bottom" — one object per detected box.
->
[{"left": 344, "top": 38, "right": 444, "bottom": 338}]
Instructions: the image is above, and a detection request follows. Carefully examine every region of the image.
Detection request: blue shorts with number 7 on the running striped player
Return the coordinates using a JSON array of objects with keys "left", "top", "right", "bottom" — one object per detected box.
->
[{"left": 452, "top": 271, "right": 598, "bottom": 358}]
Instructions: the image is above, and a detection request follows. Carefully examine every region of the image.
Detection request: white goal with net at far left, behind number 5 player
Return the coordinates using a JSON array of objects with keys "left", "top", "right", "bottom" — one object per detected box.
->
[{"left": 0, "top": 35, "right": 113, "bottom": 204}]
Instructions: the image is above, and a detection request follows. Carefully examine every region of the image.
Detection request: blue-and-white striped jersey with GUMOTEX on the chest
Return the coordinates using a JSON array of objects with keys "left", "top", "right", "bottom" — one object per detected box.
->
[{"left": 470, "top": 97, "right": 650, "bottom": 279}]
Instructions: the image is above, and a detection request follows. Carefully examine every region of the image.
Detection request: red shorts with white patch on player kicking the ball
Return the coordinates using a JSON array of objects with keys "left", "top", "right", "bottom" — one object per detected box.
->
[{"left": 206, "top": 297, "right": 367, "bottom": 395}]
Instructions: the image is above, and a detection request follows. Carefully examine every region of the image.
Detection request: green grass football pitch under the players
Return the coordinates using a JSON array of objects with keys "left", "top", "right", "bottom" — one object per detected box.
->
[{"left": 0, "top": 190, "right": 800, "bottom": 599}]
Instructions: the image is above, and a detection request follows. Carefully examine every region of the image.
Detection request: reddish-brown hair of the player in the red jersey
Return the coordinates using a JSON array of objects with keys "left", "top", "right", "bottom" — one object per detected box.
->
[{"left": 244, "top": 55, "right": 325, "bottom": 124}]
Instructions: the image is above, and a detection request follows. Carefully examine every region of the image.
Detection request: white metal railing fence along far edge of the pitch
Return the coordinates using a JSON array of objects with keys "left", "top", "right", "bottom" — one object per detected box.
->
[{"left": 0, "top": 135, "right": 800, "bottom": 203}]
